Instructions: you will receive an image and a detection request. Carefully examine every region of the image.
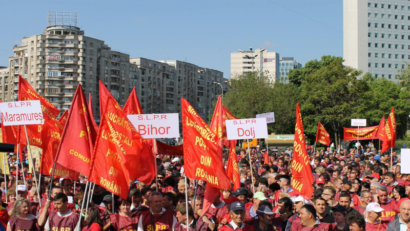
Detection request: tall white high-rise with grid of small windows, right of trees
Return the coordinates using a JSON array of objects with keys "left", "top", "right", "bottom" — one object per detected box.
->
[{"left": 343, "top": 0, "right": 410, "bottom": 81}]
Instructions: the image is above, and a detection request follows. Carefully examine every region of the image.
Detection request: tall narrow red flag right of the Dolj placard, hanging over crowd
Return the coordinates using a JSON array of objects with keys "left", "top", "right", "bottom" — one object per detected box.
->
[{"left": 291, "top": 103, "right": 313, "bottom": 200}]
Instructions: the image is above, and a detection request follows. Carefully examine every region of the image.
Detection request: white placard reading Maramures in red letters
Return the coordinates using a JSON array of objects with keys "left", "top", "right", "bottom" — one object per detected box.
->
[{"left": 0, "top": 100, "right": 43, "bottom": 126}]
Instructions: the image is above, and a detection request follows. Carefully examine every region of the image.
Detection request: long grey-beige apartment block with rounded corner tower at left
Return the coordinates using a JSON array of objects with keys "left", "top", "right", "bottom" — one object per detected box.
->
[{"left": 0, "top": 12, "right": 228, "bottom": 120}]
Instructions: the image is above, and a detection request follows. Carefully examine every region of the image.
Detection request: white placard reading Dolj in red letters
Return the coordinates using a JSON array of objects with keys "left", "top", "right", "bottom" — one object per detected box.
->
[{"left": 225, "top": 118, "right": 268, "bottom": 140}]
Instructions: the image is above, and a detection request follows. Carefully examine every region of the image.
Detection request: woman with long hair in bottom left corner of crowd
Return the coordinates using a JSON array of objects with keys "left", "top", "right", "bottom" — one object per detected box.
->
[{"left": 7, "top": 198, "right": 40, "bottom": 231}]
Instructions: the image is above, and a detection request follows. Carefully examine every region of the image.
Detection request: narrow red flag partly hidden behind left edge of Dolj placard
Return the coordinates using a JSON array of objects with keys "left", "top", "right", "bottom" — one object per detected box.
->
[{"left": 210, "top": 96, "right": 238, "bottom": 147}]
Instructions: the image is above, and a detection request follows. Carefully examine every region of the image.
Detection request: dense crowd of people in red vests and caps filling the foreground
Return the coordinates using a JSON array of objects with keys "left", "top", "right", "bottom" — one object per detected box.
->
[{"left": 0, "top": 142, "right": 410, "bottom": 231}]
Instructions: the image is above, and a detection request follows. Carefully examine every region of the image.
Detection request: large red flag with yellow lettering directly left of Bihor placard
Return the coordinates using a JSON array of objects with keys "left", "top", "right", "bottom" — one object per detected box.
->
[{"left": 89, "top": 97, "right": 155, "bottom": 198}]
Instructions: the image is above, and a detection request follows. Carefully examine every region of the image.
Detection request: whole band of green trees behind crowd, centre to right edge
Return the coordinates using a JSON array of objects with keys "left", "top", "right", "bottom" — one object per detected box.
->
[{"left": 221, "top": 56, "right": 410, "bottom": 146}]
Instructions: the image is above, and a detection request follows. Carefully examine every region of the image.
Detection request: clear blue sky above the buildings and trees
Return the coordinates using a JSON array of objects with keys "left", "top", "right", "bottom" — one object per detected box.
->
[{"left": 0, "top": 0, "right": 343, "bottom": 78}]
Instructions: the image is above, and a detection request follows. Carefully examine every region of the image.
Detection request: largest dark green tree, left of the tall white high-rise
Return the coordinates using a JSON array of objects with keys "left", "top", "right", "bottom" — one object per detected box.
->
[{"left": 301, "top": 56, "right": 369, "bottom": 144}]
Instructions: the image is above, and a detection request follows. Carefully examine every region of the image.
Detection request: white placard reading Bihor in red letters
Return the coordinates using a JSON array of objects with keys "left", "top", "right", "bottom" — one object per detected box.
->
[{"left": 127, "top": 113, "right": 179, "bottom": 139}]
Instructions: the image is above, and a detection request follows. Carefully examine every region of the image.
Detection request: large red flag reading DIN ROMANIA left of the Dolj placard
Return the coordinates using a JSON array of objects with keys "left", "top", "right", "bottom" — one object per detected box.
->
[{"left": 181, "top": 99, "right": 231, "bottom": 189}]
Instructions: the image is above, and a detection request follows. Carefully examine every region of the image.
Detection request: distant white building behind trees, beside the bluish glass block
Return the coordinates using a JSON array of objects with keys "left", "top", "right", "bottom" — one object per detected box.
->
[{"left": 231, "top": 48, "right": 279, "bottom": 82}]
